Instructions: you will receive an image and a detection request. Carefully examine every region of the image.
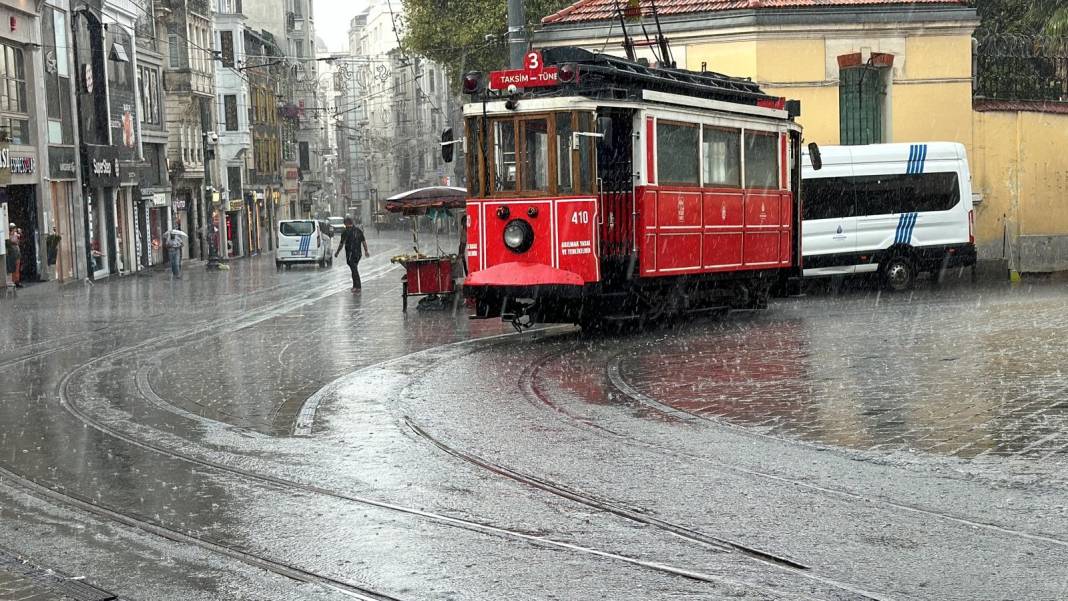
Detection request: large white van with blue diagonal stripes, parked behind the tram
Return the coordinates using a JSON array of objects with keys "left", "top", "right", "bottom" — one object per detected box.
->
[{"left": 801, "top": 142, "right": 975, "bottom": 290}]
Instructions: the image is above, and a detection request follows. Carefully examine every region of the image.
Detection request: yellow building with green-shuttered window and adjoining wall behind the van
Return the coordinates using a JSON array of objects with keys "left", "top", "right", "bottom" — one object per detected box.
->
[{"left": 534, "top": 0, "right": 1068, "bottom": 274}]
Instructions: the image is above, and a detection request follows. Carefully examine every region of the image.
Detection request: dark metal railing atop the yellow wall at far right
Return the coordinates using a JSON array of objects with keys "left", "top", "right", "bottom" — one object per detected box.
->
[{"left": 973, "top": 34, "right": 1068, "bottom": 101}]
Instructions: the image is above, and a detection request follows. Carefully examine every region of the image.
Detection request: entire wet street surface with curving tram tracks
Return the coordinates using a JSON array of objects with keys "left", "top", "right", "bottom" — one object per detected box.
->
[{"left": 0, "top": 235, "right": 1068, "bottom": 601}]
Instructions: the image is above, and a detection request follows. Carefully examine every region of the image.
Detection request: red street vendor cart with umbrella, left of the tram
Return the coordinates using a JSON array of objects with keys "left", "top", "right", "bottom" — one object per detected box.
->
[{"left": 386, "top": 186, "right": 467, "bottom": 312}]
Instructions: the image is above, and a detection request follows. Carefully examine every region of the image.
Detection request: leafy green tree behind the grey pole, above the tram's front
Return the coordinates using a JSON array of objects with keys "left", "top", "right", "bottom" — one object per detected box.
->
[{"left": 402, "top": 0, "right": 571, "bottom": 81}]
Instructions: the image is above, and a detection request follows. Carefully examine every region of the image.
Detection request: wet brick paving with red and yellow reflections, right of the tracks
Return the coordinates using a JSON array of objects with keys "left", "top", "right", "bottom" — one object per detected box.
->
[{"left": 616, "top": 284, "right": 1068, "bottom": 460}]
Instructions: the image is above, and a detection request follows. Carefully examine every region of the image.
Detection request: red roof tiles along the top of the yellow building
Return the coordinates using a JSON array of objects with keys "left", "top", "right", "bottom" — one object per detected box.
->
[{"left": 541, "top": 0, "right": 964, "bottom": 25}]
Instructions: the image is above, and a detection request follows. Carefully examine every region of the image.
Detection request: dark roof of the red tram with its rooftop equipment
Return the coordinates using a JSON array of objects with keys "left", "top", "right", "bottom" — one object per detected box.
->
[{"left": 478, "top": 46, "right": 780, "bottom": 106}]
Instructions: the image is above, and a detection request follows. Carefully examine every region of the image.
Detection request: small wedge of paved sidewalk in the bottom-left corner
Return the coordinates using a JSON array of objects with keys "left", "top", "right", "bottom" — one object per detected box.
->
[{"left": 0, "top": 549, "right": 119, "bottom": 601}]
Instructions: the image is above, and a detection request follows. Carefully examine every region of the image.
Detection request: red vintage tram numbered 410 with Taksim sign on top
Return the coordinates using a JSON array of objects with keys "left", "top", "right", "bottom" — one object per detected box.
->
[{"left": 464, "top": 48, "right": 801, "bottom": 327}]
